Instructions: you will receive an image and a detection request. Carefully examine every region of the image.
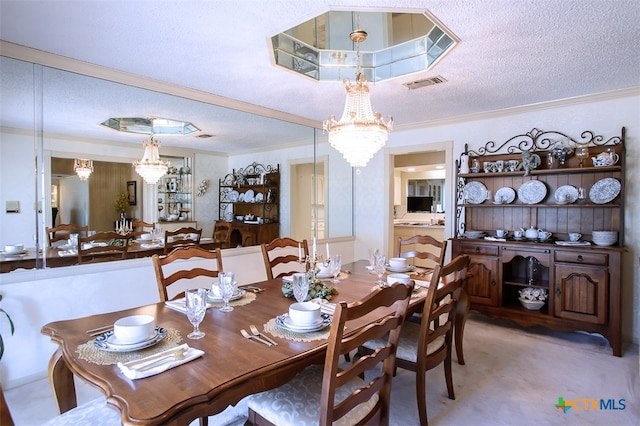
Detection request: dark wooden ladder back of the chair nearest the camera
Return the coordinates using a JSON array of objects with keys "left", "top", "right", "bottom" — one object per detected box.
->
[{"left": 320, "top": 283, "right": 413, "bottom": 425}]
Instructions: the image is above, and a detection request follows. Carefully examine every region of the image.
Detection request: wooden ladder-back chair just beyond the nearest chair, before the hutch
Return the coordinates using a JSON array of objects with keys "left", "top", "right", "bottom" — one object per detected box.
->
[{"left": 358, "top": 256, "right": 469, "bottom": 425}]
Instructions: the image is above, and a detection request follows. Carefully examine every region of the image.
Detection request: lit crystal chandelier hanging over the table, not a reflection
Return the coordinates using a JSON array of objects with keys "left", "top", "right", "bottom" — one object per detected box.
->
[{"left": 323, "top": 28, "right": 393, "bottom": 167}]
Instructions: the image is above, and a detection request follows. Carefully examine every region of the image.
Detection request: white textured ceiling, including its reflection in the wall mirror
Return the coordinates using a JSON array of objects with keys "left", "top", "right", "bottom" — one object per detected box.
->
[{"left": 0, "top": 0, "right": 640, "bottom": 152}]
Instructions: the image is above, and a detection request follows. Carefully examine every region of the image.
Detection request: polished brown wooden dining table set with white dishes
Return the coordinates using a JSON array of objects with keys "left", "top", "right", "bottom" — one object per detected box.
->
[{"left": 41, "top": 261, "right": 464, "bottom": 425}]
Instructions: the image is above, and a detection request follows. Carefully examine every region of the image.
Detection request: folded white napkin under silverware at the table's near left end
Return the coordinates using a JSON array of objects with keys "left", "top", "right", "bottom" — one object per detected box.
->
[{"left": 118, "top": 343, "right": 204, "bottom": 380}]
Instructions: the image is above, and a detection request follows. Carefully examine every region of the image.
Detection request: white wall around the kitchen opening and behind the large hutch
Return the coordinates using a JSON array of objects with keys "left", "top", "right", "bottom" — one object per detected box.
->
[{"left": 355, "top": 89, "right": 640, "bottom": 343}]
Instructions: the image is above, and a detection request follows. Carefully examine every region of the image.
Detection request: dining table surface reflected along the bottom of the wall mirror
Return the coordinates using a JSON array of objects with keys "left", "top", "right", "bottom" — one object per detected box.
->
[{"left": 0, "top": 238, "right": 224, "bottom": 273}]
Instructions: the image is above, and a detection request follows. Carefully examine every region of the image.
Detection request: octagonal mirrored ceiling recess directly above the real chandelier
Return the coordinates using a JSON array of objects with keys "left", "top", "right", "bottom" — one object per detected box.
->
[{"left": 271, "top": 11, "right": 459, "bottom": 82}]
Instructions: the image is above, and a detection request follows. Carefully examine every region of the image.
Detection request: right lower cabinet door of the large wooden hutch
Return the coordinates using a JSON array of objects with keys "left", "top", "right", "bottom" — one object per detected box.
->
[{"left": 555, "top": 265, "right": 609, "bottom": 324}]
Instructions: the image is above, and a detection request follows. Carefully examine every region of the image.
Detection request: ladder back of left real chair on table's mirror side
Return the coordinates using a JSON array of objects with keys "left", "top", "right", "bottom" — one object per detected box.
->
[{"left": 151, "top": 246, "right": 222, "bottom": 302}]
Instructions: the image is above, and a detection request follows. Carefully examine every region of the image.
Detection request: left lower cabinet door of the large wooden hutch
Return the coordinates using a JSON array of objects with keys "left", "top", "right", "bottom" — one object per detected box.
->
[{"left": 466, "top": 256, "right": 499, "bottom": 306}]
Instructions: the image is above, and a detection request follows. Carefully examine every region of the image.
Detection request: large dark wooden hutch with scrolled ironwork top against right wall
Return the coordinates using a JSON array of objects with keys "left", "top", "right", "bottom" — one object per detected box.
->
[{"left": 452, "top": 128, "right": 625, "bottom": 356}]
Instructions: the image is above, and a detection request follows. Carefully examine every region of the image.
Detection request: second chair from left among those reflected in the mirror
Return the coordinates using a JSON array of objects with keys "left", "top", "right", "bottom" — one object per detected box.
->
[{"left": 78, "top": 231, "right": 133, "bottom": 263}]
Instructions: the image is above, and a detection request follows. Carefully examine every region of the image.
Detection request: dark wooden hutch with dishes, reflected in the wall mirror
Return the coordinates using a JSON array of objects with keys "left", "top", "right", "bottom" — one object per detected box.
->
[{"left": 218, "top": 163, "right": 280, "bottom": 247}]
